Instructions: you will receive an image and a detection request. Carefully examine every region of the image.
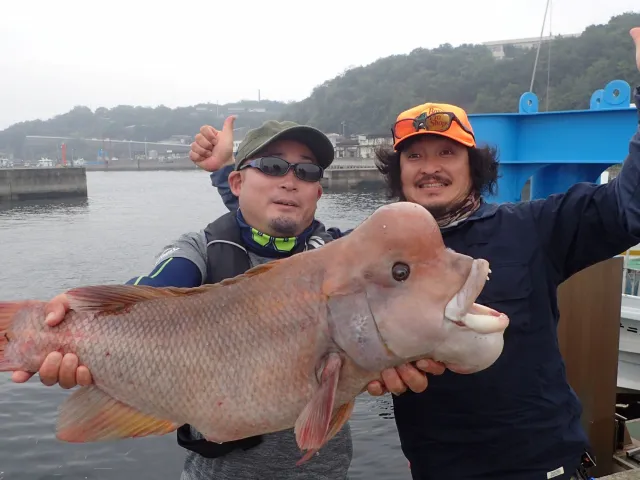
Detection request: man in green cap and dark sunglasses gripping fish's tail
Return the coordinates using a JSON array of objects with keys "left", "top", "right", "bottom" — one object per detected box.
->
[{"left": 13, "top": 121, "right": 352, "bottom": 480}]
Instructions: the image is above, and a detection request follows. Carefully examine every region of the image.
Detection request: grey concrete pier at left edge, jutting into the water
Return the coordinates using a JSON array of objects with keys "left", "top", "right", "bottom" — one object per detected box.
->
[{"left": 0, "top": 167, "right": 87, "bottom": 202}]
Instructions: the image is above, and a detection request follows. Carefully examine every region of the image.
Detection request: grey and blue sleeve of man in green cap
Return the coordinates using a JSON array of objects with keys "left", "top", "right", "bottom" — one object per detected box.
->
[{"left": 126, "top": 231, "right": 207, "bottom": 288}]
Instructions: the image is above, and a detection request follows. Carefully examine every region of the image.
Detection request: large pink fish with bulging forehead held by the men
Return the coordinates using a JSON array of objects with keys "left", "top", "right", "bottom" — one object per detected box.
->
[{"left": 0, "top": 203, "right": 508, "bottom": 462}]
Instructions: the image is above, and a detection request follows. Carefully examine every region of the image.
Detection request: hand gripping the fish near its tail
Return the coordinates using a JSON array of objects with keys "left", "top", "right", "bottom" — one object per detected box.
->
[{"left": 11, "top": 294, "right": 93, "bottom": 389}]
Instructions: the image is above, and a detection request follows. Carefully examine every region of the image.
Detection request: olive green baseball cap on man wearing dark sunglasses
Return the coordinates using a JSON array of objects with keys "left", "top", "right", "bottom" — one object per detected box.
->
[{"left": 235, "top": 120, "right": 334, "bottom": 170}]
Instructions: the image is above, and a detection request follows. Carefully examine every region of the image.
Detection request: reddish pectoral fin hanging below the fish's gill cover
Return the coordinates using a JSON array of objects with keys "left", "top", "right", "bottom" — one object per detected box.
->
[{"left": 295, "top": 353, "right": 342, "bottom": 450}]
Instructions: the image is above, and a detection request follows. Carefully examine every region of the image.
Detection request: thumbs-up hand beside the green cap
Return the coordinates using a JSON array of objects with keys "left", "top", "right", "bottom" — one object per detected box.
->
[{"left": 189, "top": 115, "right": 236, "bottom": 172}]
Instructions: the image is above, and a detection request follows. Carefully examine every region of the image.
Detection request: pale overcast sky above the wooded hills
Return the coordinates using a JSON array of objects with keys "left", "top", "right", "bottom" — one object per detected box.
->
[{"left": 0, "top": 0, "right": 640, "bottom": 129}]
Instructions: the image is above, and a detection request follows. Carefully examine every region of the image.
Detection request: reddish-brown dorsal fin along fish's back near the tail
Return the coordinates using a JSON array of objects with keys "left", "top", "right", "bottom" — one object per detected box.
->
[{"left": 65, "top": 285, "right": 219, "bottom": 312}]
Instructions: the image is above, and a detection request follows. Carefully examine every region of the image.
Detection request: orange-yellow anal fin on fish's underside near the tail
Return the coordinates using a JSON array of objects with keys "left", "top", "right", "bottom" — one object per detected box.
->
[{"left": 56, "top": 385, "right": 179, "bottom": 443}]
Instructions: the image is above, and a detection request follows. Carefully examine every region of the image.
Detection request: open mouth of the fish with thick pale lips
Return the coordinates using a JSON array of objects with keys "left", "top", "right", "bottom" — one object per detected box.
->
[{"left": 444, "top": 259, "right": 509, "bottom": 334}]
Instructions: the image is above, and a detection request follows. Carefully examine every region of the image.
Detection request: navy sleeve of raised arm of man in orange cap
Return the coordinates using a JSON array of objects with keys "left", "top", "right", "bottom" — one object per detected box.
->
[{"left": 529, "top": 87, "right": 640, "bottom": 284}]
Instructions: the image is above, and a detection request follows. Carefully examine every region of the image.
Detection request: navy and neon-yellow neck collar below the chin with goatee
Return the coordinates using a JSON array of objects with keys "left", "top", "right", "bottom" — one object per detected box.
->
[{"left": 236, "top": 208, "right": 319, "bottom": 258}]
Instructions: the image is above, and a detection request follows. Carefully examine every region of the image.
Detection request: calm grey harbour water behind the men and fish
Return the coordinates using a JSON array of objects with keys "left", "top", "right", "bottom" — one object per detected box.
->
[{"left": 0, "top": 171, "right": 410, "bottom": 480}]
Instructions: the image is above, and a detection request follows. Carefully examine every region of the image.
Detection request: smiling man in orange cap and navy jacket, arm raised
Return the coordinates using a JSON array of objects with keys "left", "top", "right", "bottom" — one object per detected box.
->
[{"left": 191, "top": 28, "right": 640, "bottom": 480}]
